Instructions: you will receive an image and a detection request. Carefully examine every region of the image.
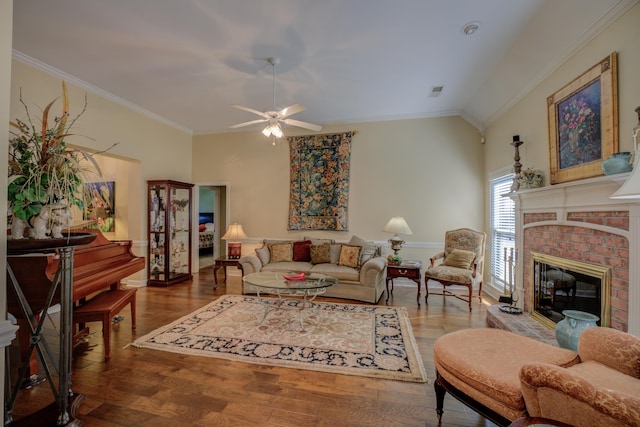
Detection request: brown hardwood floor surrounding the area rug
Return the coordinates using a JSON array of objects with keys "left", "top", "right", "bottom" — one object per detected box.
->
[{"left": 8, "top": 267, "right": 494, "bottom": 427}]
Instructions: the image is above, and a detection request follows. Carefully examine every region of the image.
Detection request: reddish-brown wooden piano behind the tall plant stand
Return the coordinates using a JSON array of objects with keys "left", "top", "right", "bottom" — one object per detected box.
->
[{"left": 7, "top": 229, "right": 145, "bottom": 382}]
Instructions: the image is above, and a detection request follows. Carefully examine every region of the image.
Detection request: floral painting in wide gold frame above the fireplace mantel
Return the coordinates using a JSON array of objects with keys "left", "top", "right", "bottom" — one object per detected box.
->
[{"left": 547, "top": 52, "right": 618, "bottom": 184}]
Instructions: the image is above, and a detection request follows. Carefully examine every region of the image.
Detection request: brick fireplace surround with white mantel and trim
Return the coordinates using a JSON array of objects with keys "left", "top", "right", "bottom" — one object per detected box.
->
[{"left": 511, "top": 174, "right": 640, "bottom": 336}]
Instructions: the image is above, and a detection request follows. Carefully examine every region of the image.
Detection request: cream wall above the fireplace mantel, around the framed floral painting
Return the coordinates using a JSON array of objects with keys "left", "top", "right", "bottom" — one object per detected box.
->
[{"left": 484, "top": 4, "right": 640, "bottom": 290}]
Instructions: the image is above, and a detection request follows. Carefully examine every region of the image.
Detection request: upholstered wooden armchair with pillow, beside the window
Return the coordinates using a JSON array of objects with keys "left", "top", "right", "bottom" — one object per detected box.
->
[{"left": 424, "top": 228, "right": 486, "bottom": 311}]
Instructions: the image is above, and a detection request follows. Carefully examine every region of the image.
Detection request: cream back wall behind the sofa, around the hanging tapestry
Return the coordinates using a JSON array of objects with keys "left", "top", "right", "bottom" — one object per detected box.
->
[{"left": 193, "top": 117, "right": 484, "bottom": 262}]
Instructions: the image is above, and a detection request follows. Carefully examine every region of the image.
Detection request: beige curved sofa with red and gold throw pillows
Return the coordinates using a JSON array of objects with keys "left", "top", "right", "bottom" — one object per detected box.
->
[{"left": 239, "top": 236, "right": 387, "bottom": 304}]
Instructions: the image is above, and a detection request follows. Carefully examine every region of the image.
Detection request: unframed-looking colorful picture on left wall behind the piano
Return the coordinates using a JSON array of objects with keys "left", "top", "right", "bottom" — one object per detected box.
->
[{"left": 84, "top": 181, "right": 116, "bottom": 232}]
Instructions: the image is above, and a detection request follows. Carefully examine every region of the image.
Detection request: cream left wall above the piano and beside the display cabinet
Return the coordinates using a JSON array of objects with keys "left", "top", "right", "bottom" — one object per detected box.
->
[{"left": 10, "top": 60, "right": 191, "bottom": 241}]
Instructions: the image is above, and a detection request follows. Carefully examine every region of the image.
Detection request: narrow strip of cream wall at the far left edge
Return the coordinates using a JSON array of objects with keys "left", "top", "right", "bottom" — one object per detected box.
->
[{"left": 0, "top": 0, "right": 13, "bottom": 414}]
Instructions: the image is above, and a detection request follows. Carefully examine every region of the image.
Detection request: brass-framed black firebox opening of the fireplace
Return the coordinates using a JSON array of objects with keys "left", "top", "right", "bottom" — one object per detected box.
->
[{"left": 531, "top": 252, "right": 611, "bottom": 328}]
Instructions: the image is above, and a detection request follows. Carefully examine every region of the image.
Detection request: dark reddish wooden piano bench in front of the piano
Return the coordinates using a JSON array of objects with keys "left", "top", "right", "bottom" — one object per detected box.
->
[{"left": 73, "top": 288, "right": 136, "bottom": 361}]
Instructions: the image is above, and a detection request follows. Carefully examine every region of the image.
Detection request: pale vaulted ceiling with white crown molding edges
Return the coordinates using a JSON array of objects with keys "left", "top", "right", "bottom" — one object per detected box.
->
[{"left": 13, "top": 0, "right": 637, "bottom": 133}]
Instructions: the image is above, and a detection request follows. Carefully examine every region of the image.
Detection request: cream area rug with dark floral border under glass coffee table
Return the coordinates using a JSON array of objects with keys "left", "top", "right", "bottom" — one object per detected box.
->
[{"left": 133, "top": 295, "right": 427, "bottom": 382}]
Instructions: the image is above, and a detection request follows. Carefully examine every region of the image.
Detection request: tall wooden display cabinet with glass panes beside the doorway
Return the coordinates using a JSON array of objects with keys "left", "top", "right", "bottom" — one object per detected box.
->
[{"left": 147, "top": 180, "right": 193, "bottom": 286}]
